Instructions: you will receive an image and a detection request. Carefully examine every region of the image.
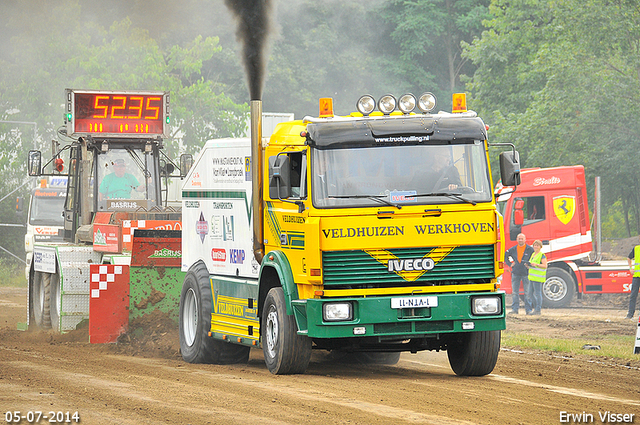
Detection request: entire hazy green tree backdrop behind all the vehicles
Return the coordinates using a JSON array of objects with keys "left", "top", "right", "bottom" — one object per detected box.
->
[{"left": 0, "top": 0, "right": 640, "bottom": 245}]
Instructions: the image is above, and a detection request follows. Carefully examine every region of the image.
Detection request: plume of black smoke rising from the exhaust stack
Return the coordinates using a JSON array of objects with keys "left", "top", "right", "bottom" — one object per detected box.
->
[{"left": 225, "top": 0, "right": 271, "bottom": 100}]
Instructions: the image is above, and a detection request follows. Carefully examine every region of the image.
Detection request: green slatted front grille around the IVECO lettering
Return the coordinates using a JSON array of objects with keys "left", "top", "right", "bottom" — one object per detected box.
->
[{"left": 322, "top": 245, "right": 495, "bottom": 289}]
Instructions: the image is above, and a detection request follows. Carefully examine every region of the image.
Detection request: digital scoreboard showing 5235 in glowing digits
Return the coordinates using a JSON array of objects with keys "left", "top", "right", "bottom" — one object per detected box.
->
[{"left": 65, "top": 89, "right": 169, "bottom": 137}]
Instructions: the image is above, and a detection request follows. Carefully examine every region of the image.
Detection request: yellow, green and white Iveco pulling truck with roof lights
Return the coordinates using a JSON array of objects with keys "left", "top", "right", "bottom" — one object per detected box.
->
[{"left": 179, "top": 93, "right": 520, "bottom": 376}]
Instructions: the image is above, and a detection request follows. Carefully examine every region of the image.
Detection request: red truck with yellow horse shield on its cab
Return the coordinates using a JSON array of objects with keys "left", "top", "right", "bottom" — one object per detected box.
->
[{"left": 496, "top": 165, "right": 632, "bottom": 307}]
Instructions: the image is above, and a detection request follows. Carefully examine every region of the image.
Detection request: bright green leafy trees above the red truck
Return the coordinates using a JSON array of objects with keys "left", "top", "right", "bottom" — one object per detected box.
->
[{"left": 465, "top": 0, "right": 640, "bottom": 234}]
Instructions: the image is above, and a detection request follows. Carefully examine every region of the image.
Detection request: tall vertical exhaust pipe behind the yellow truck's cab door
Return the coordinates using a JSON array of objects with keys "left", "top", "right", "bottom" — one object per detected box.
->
[{"left": 251, "top": 100, "right": 264, "bottom": 264}]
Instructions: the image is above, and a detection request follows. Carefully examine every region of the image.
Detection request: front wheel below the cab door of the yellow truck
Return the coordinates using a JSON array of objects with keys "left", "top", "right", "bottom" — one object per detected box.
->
[{"left": 261, "top": 287, "right": 311, "bottom": 375}]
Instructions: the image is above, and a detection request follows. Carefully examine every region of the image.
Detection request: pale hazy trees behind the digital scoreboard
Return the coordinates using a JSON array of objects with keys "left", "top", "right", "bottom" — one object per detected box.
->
[{"left": 0, "top": 0, "right": 248, "bottom": 258}]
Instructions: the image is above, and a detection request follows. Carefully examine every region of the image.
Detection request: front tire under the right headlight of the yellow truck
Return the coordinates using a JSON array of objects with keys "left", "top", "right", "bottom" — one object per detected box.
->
[{"left": 447, "top": 331, "right": 500, "bottom": 376}]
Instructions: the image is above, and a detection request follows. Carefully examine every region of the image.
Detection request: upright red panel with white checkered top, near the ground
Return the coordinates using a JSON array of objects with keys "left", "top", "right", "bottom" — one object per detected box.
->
[{"left": 89, "top": 264, "right": 129, "bottom": 344}]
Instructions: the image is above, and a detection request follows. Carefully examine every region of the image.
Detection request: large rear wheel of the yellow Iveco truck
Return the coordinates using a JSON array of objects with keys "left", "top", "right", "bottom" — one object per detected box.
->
[{"left": 179, "top": 262, "right": 251, "bottom": 364}]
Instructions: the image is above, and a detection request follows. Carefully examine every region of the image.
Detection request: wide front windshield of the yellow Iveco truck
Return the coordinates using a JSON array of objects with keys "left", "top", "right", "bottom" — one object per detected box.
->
[{"left": 312, "top": 140, "right": 492, "bottom": 208}]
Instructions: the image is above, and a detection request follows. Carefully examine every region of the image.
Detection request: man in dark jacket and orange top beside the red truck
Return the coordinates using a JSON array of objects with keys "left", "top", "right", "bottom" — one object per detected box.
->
[{"left": 504, "top": 233, "right": 534, "bottom": 314}]
